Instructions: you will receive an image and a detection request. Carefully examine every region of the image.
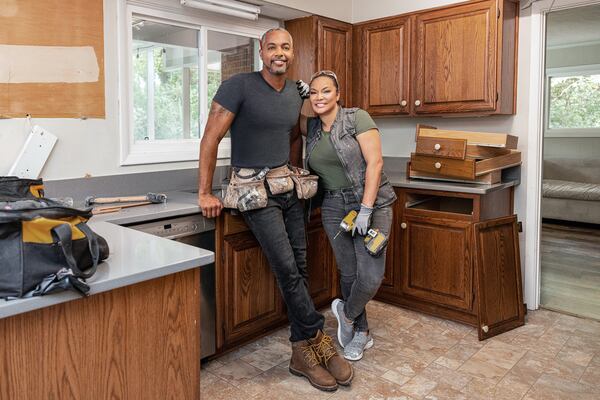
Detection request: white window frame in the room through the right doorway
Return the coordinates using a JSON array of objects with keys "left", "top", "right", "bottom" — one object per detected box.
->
[{"left": 544, "top": 64, "right": 600, "bottom": 138}]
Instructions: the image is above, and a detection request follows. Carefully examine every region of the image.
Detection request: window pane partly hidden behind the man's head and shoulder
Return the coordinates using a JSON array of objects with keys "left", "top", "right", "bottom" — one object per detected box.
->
[{"left": 207, "top": 31, "right": 262, "bottom": 136}]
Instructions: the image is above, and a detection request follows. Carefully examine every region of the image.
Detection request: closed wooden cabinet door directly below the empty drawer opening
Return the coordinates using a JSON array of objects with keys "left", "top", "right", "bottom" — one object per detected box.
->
[{"left": 401, "top": 215, "right": 473, "bottom": 311}]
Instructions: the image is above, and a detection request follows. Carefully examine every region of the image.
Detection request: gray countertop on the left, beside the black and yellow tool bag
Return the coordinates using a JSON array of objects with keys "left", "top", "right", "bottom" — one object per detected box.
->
[{"left": 0, "top": 209, "right": 215, "bottom": 318}]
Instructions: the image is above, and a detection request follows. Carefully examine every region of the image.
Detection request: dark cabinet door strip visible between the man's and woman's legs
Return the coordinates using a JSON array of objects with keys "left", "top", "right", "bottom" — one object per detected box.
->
[{"left": 306, "top": 217, "right": 337, "bottom": 308}]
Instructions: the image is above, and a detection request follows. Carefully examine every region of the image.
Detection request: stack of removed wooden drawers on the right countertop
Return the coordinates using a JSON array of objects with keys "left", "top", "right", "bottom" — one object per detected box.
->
[{"left": 408, "top": 125, "right": 521, "bottom": 184}]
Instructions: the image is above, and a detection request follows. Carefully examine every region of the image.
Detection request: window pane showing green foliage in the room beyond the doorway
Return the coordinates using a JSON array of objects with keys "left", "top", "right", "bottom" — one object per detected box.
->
[{"left": 548, "top": 75, "right": 600, "bottom": 129}]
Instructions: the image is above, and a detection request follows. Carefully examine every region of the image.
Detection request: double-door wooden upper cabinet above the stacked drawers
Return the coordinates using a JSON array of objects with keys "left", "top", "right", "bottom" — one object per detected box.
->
[{"left": 354, "top": 0, "right": 518, "bottom": 116}]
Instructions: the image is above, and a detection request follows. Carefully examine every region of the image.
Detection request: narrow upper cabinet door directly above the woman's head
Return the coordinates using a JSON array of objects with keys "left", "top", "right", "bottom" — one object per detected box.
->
[{"left": 314, "top": 17, "right": 352, "bottom": 107}]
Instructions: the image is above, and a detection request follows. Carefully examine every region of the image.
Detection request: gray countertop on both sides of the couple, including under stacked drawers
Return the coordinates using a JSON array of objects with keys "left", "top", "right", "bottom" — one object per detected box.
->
[{"left": 0, "top": 170, "right": 520, "bottom": 318}]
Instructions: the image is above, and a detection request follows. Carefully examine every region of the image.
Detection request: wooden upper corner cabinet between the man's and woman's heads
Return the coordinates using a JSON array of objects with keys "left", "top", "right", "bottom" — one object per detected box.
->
[{"left": 285, "top": 15, "right": 352, "bottom": 106}]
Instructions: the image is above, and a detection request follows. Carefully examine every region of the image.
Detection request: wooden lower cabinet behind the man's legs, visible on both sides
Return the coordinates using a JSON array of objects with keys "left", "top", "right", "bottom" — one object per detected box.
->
[{"left": 215, "top": 212, "right": 338, "bottom": 355}]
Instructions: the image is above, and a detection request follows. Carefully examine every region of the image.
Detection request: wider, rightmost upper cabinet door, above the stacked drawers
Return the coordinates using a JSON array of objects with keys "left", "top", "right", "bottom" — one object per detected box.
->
[{"left": 413, "top": 0, "right": 498, "bottom": 114}]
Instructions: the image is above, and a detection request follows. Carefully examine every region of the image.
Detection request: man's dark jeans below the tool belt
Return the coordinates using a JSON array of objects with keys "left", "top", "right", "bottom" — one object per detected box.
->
[{"left": 242, "top": 190, "right": 324, "bottom": 342}]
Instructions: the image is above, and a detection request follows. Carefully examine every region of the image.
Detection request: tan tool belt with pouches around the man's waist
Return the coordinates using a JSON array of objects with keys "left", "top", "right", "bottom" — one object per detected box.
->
[{"left": 223, "top": 165, "right": 319, "bottom": 211}]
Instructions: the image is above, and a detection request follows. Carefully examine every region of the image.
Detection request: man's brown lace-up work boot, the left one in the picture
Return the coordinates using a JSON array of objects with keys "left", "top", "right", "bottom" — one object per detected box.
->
[{"left": 290, "top": 340, "right": 337, "bottom": 392}]
